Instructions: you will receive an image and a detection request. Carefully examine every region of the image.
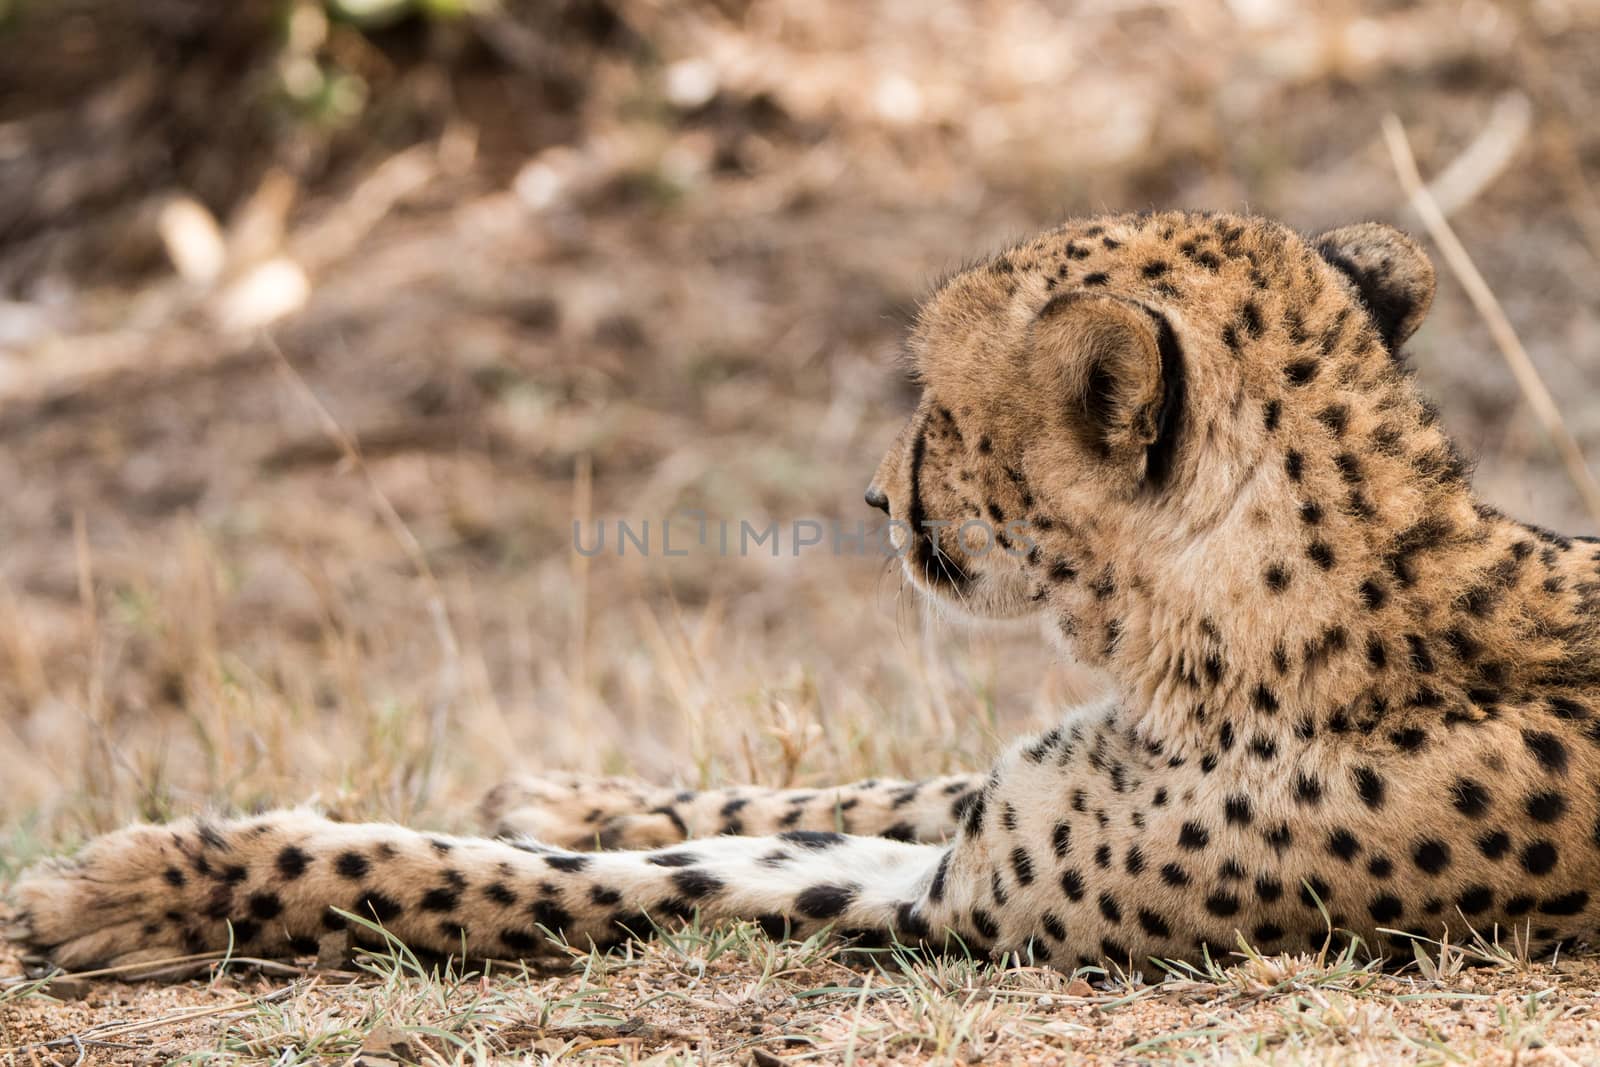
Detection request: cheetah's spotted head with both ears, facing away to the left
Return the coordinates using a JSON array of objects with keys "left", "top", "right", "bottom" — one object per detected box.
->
[{"left": 867, "top": 213, "right": 1459, "bottom": 643}]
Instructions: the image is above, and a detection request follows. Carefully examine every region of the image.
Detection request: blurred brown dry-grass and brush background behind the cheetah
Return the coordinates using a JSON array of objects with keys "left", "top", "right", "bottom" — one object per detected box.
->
[{"left": 0, "top": 0, "right": 1600, "bottom": 851}]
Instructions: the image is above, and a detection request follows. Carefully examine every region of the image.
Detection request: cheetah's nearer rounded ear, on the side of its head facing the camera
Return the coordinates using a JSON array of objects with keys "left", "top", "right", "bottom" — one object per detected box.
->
[{"left": 1032, "top": 291, "right": 1163, "bottom": 459}]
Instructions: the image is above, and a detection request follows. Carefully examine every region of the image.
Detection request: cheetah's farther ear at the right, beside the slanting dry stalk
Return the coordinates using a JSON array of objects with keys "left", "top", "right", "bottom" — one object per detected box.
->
[{"left": 1317, "top": 222, "right": 1434, "bottom": 354}]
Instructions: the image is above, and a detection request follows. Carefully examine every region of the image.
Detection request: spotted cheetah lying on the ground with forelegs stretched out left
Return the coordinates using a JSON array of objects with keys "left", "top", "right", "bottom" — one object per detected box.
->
[{"left": 11, "top": 213, "right": 1600, "bottom": 968}]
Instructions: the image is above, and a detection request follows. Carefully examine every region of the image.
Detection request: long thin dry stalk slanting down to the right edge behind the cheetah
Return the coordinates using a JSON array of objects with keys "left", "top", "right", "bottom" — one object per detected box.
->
[{"left": 1384, "top": 114, "right": 1600, "bottom": 523}]
